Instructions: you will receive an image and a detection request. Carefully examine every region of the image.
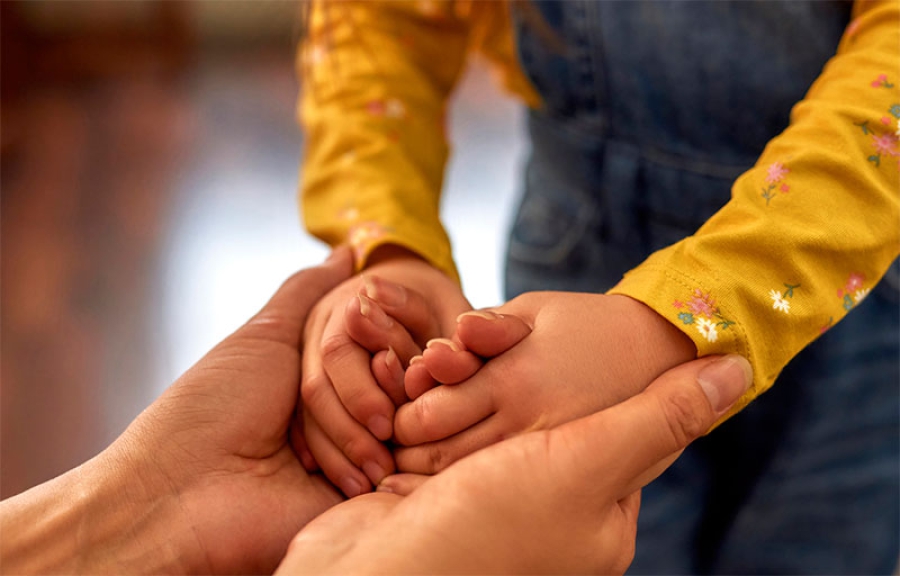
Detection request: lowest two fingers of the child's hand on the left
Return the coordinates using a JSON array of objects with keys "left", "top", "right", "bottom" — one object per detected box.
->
[{"left": 303, "top": 376, "right": 394, "bottom": 488}]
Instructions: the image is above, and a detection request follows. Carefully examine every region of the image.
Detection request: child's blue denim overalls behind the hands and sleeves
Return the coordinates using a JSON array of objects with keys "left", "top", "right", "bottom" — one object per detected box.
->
[{"left": 506, "top": 0, "right": 900, "bottom": 574}]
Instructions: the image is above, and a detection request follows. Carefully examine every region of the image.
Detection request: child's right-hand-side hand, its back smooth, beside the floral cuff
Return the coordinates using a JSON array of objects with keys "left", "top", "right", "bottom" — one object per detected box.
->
[{"left": 394, "top": 292, "right": 696, "bottom": 474}]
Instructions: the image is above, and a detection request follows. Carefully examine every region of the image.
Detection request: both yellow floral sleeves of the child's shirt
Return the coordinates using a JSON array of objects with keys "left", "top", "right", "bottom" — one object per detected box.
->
[{"left": 298, "top": 0, "right": 900, "bottom": 411}]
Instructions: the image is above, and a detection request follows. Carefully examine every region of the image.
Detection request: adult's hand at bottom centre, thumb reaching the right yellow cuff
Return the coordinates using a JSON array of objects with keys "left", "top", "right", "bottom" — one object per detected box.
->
[{"left": 276, "top": 356, "right": 751, "bottom": 574}]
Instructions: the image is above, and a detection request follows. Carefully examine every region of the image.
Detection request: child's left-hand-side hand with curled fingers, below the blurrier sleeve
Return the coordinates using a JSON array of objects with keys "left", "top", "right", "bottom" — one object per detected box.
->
[{"left": 301, "top": 246, "right": 471, "bottom": 497}]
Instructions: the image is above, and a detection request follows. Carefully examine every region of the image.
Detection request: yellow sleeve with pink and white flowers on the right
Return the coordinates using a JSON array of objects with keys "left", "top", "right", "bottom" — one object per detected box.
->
[{"left": 612, "top": 0, "right": 900, "bottom": 413}]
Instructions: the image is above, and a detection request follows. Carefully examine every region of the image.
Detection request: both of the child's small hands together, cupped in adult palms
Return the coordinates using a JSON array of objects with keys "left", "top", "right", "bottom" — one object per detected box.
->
[{"left": 291, "top": 257, "right": 697, "bottom": 497}]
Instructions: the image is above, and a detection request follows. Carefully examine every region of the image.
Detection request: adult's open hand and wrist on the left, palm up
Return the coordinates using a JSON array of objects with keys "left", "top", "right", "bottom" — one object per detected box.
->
[{"left": 0, "top": 248, "right": 351, "bottom": 574}]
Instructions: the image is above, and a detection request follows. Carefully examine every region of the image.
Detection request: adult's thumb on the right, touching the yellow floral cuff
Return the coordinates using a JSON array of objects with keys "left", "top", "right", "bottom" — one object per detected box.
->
[{"left": 548, "top": 355, "right": 752, "bottom": 500}]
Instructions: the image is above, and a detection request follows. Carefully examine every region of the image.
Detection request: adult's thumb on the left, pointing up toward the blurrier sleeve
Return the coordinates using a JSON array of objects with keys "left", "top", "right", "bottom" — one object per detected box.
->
[{"left": 238, "top": 246, "right": 353, "bottom": 348}]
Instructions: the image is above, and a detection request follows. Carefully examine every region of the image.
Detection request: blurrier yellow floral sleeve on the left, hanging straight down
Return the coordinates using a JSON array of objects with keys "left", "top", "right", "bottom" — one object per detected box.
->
[{"left": 297, "top": 0, "right": 469, "bottom": 279}]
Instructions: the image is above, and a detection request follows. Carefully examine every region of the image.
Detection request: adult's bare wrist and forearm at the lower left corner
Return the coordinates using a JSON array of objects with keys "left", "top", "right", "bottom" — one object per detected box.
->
[{"left": 0, "top": 440, "right": 197, "bottom": 574}]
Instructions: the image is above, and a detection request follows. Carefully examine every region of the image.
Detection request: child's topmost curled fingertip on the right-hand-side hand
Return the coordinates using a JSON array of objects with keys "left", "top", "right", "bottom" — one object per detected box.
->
[{"left": 456, "top": 310, "right": 532, "bottom": 358}]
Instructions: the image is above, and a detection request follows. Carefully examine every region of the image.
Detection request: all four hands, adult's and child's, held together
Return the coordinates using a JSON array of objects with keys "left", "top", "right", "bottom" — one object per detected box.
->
[{"left": 0, "top": 249, "right": 749, "bottom": 574}]
